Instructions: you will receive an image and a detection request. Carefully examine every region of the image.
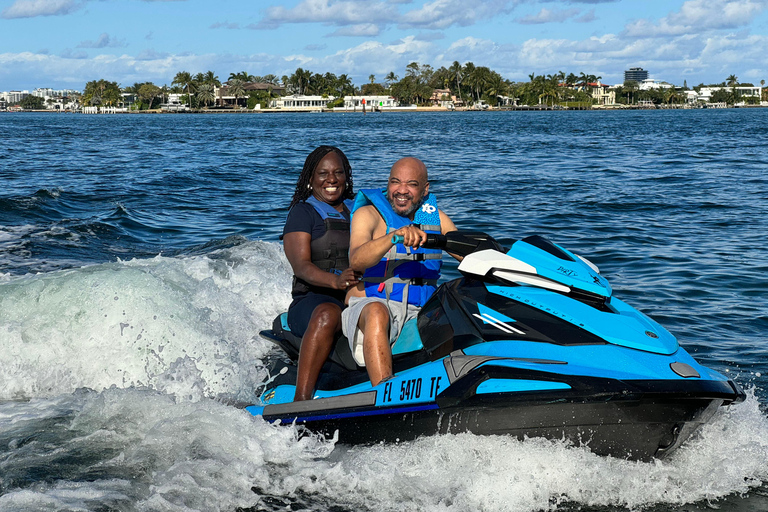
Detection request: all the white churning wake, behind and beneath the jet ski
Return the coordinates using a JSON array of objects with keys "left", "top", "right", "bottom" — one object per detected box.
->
[{"left": 0, "top": 242, "right": 768, "bottom": 512}]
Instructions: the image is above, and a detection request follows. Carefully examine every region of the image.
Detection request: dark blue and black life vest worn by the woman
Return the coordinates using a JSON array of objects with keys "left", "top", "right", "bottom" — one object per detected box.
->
[{"left": 291, "top": 196, "right": 354, "bottom": 297}]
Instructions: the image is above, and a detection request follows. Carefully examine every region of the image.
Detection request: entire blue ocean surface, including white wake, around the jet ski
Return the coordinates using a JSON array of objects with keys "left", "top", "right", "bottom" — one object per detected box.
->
[{"left": 0, "top": 109, "right": 768, "bottom": 512}]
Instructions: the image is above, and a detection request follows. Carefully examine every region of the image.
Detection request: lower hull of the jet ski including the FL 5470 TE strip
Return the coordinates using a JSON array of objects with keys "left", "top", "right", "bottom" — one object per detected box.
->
[{"left": 249, "top": 356, "right": 744, "bottom": 460}]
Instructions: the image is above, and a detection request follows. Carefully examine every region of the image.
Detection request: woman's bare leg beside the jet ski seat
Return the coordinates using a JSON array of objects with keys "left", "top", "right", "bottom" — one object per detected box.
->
[{"left": 293, "top": 302, "right": 341, "bottom": 402}]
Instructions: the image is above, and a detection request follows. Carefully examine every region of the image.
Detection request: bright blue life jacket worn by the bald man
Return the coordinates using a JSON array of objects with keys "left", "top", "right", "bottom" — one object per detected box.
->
[{"left": 352, "top": 189, "right": 443, "bottom": 307}]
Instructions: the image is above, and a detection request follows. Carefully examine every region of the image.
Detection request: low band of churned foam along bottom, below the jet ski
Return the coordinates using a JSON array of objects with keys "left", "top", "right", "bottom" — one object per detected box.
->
[{"left": 0, "top": 388, "right": 768, "bottom": 512}]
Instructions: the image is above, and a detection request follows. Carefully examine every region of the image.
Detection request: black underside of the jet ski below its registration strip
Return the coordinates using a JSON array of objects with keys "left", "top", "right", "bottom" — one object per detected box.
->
[{"left": 264, "top": 399, "right": 723, "bottom": 460}]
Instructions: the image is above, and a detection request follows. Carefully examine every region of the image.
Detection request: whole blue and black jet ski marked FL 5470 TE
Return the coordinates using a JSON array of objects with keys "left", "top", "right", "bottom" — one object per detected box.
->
[{"left": 246, "top": 231, "right": 745, "bottom": 460}]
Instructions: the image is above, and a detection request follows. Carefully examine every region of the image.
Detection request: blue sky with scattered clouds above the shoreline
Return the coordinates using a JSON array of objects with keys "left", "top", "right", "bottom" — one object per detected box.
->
[{"left": 0, "top": 0, "right": 768, "bottom": 91}]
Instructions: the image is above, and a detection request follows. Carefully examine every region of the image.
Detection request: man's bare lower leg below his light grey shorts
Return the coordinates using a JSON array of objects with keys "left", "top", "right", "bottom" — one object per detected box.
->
[{"left": 357, "top": 302, "right": 392, "bottom": 386}]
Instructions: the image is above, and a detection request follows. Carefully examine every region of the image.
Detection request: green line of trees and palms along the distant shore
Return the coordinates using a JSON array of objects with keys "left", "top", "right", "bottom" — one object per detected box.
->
[{"left": 76, "top": 66, "right": 765, "bottom": 109}]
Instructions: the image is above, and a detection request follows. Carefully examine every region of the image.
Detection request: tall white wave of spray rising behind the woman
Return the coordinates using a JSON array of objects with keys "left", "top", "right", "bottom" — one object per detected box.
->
[{"left": 0, "top": 242, "right": 291, "bottom": 400}]
